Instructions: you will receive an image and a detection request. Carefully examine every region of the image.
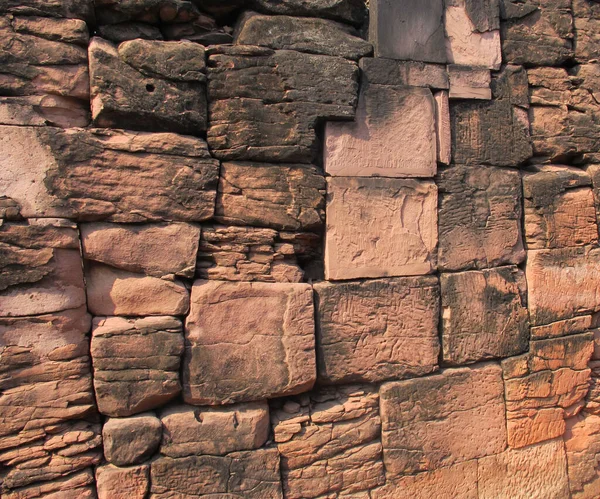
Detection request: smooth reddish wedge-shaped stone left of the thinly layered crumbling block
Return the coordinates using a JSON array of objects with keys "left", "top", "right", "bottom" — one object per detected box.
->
[{"left": 80, "top": 223, "right": 200, "bottom": 277}]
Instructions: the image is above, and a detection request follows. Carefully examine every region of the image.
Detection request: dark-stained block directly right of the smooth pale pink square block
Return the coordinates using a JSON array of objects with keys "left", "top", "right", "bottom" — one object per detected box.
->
[{"left": 437, "top": 165, "right": 525, "bottom": 270}]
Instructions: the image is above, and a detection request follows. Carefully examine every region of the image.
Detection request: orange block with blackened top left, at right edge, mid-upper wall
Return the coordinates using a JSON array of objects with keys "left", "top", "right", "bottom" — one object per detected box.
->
[{"left": 523, "top": 166, "right": 598, "bottom": 249}]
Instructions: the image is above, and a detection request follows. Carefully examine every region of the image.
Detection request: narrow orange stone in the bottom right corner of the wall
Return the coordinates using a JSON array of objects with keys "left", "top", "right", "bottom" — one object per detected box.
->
[{"left": 564, "top": 414, "right": 600, "bottom": 499}]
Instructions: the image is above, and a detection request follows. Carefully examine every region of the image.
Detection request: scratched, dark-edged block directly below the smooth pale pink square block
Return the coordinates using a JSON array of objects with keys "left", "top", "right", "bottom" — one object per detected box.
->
[{"left": 314, "top": 276, "right": 440, "bottom": 383}]
